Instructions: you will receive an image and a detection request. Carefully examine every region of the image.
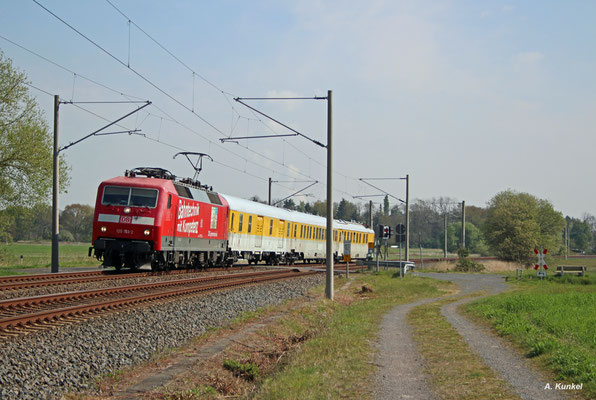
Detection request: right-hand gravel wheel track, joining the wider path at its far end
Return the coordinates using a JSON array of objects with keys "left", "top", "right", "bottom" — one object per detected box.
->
[{"left": 424, "top": 273, "right": 568, "bottom": 400}]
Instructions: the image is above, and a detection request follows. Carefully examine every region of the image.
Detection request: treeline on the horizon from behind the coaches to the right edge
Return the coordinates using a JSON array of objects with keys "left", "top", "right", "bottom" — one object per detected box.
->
[{"left": 264, "top": 190, "right": 596, "bottom": 262}]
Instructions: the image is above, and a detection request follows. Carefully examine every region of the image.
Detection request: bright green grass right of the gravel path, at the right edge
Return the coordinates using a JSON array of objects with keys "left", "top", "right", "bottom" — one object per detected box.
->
[{"left": 466, "top": 276, "right": 596, "bottom": 398}]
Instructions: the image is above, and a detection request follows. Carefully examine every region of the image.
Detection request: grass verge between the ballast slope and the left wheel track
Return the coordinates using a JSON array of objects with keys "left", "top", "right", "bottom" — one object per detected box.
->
[{"left": 254, "top": 272, "right": 448, "bottom": 399}]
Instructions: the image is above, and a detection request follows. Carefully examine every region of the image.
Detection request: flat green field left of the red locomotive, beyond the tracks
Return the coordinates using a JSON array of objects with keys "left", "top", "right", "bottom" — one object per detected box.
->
[{"left": 0, "top": 242, "right": 100, "bottom": 275}]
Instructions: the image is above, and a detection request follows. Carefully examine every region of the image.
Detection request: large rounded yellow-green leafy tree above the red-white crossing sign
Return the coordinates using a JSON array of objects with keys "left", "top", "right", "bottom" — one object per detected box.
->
[{"left": 484, "top": 190, "right": 565, "bottom": 263}]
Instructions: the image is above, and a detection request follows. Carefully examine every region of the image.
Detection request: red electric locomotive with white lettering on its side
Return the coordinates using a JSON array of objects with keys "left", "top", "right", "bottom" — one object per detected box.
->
[{"left": 90, "top": 168, "right": 228, "bottom": 270}]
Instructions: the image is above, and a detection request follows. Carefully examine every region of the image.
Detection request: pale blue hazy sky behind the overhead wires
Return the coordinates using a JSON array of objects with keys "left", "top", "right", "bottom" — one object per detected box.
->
[{"left": 0, "top": 0, "right": 596, "bottom": 217}]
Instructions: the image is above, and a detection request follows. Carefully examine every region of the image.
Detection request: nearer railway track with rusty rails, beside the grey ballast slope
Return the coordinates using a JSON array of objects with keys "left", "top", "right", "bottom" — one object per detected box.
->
[{"left": 0, "top": 269, "right": 318, "bottom": 338}]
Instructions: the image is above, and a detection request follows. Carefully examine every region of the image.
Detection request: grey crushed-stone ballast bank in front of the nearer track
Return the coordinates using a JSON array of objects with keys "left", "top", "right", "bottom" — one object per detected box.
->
[{"left": 0, "top": 274, "right": 324, "bottom": 399}]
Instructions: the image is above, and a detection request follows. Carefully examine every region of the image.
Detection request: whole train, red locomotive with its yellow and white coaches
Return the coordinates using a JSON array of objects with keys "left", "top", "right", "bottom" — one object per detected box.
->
[{"left": 89, "top": 167, "right": 374, "bottom": 271}]
